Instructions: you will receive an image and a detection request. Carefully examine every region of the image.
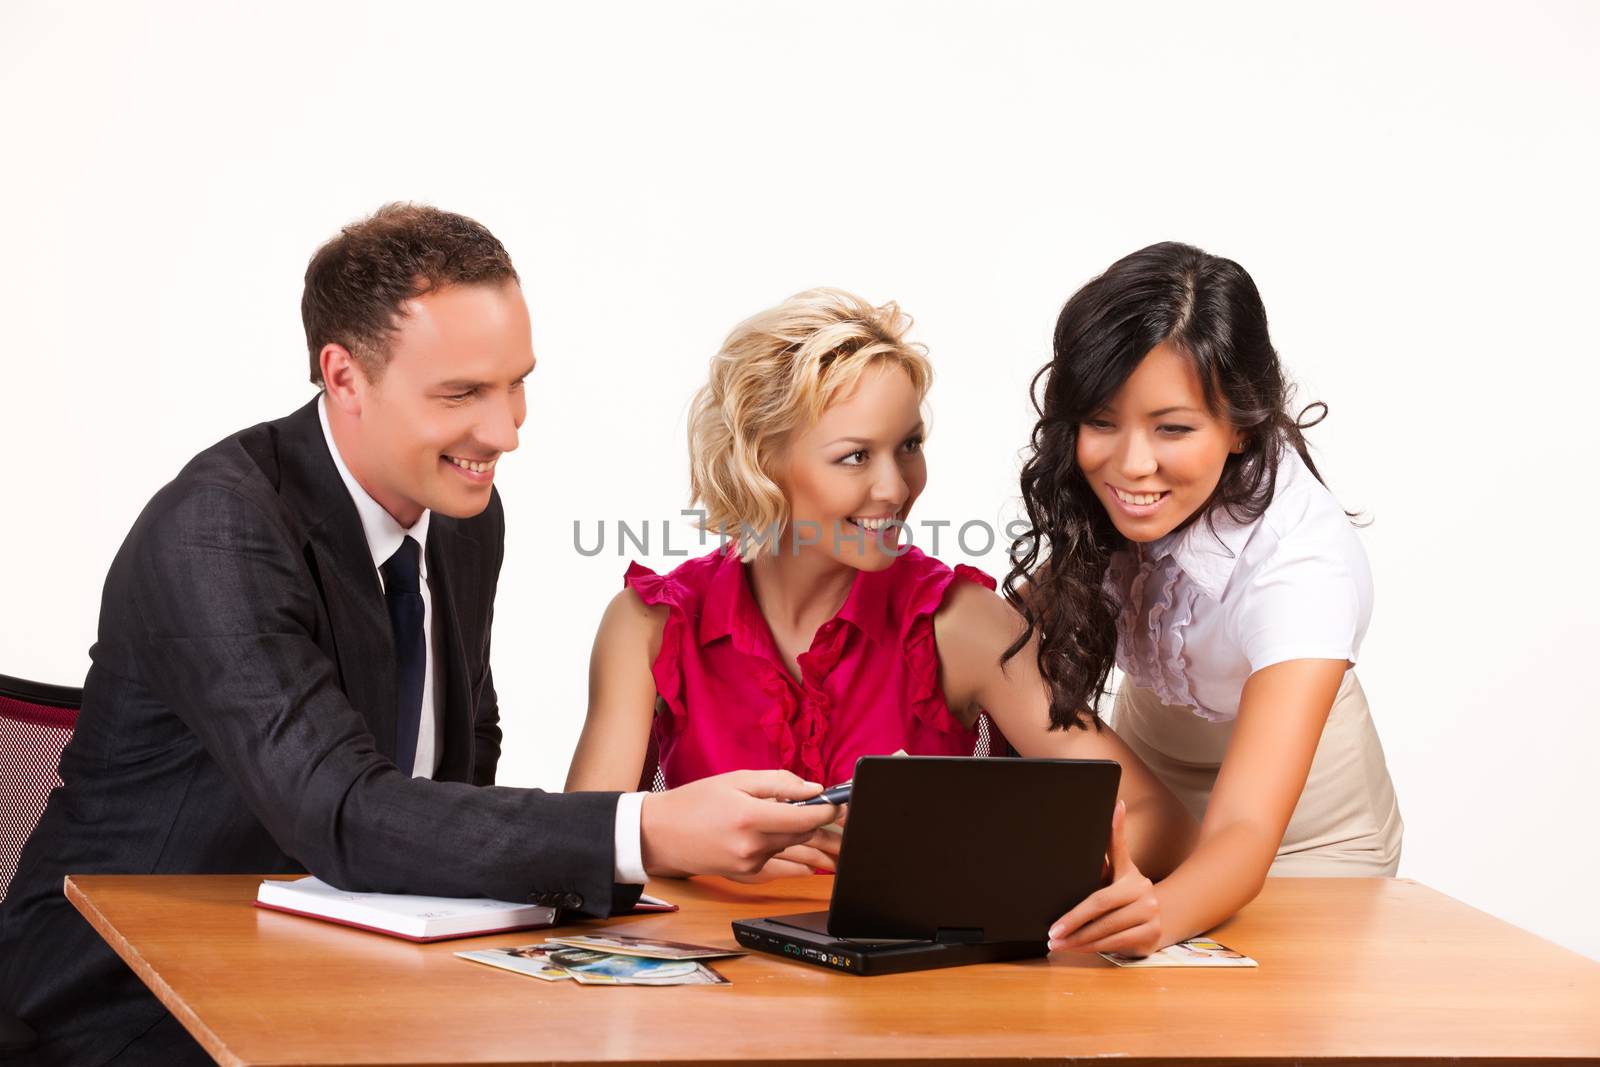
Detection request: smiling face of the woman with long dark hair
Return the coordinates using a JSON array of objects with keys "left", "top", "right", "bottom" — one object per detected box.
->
[{"left": 1077, "top": 344, "right": 1243, "bottom": 542}]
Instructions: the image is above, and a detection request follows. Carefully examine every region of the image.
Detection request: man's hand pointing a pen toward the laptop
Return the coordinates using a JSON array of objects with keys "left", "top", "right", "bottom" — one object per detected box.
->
[{"left": 638, "top": 771, "right": 838, "bottom": 878}]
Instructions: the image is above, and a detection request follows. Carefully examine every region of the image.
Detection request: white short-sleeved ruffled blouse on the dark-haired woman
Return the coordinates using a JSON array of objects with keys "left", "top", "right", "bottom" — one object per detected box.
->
[{"left": 1106, "top": 450, "right": 1373, "bottom": 721}]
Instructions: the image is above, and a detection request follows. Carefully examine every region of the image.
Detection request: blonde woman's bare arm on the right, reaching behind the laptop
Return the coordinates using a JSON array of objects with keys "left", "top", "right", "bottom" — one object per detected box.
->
[{"left": 933, "top": 582, "right": 1195, "bottom": 877}]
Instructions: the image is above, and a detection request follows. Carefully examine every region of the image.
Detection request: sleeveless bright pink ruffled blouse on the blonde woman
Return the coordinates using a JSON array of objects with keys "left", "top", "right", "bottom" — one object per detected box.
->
[{"left": 624, "top": 547, "right": 1005, "bottom": 789}]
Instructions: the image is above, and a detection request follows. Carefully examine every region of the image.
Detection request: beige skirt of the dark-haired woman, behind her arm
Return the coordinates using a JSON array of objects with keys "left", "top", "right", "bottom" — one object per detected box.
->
[{"left": 1112, "top": 670, "right": 1405, "bottom": 877}]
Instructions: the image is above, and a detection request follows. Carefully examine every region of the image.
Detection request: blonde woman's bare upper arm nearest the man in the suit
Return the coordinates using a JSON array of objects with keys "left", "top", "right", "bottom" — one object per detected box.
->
[{"left": 566, "top": 589, "right": 667, "bottom": 793}]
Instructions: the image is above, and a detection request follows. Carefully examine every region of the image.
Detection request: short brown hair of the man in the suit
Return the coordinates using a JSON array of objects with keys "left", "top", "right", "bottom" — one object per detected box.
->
[{"left": 301, "top": 203, "right": 520, "bottom": 386}]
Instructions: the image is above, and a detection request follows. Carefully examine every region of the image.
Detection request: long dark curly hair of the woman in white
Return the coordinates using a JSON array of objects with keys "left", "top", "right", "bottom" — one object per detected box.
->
[{"left": 1003, "top": 242, "right": 1328, "bottom": 729}]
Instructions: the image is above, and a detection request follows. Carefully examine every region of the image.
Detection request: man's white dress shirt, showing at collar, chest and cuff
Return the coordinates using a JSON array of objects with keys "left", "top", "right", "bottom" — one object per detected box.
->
[{"left": 317, "top": 394, "right": 650, "bottom": 885}]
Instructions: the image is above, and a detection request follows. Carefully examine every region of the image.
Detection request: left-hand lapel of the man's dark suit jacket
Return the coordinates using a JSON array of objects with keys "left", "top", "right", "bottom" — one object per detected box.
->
[{"left": 275, "top": 400, "right": 396, "bottom": 760}]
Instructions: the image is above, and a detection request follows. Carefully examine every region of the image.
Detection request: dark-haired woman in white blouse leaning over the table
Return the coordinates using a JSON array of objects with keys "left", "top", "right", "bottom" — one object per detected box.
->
[{"left": 1006, "top": 243, "right": 1402, "bottom": 953}]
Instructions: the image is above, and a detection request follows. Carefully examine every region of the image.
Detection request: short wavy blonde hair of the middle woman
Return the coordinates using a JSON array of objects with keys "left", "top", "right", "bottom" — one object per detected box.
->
[{"left": 690, "top": 288, "right": 933, "bottom": 561}]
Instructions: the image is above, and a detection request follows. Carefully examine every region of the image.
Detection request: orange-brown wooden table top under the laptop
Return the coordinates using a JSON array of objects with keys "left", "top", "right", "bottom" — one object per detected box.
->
[{"left": 67, "top": 875, "right": 1600, "bottom": 1065}]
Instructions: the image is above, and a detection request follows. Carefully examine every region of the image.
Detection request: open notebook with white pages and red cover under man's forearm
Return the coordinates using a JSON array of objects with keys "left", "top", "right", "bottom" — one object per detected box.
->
[{"left": 256, "top": 877, "right": 677, "bottom": 942}]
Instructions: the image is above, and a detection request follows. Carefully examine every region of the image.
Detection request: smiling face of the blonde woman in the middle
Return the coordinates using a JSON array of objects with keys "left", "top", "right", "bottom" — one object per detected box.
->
[{"left": 778, "top": 365, "right": 928, "bottom": 571}]
